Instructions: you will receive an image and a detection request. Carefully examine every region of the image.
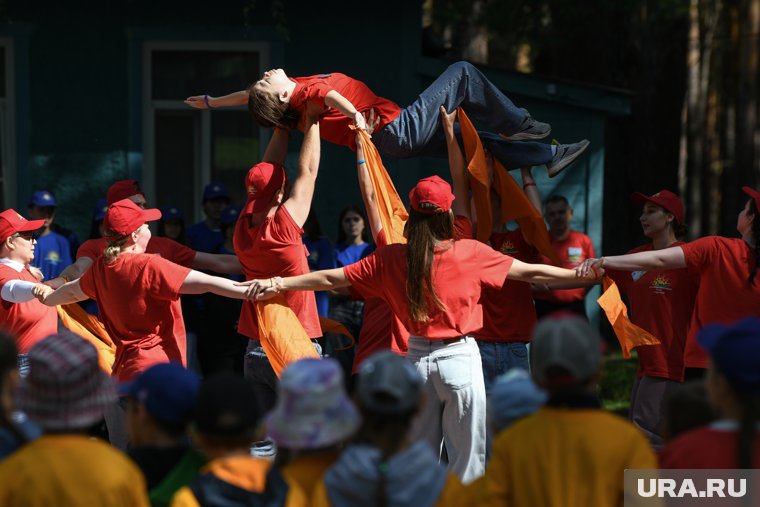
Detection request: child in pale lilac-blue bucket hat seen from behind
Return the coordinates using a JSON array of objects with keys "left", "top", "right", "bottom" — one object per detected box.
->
[{"left": 266, "top": 359, "right": 359, "bottom": 497}]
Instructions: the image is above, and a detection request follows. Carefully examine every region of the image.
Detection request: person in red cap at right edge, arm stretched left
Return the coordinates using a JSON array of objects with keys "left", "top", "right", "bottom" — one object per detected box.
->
[{"left": 576, "top": 187, "right": 760, "bottom": 362}]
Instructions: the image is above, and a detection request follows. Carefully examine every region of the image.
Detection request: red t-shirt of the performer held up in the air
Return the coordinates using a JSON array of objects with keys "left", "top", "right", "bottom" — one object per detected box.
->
[{"left": 290, "top": 72, "right": 401, "bottom": 150}]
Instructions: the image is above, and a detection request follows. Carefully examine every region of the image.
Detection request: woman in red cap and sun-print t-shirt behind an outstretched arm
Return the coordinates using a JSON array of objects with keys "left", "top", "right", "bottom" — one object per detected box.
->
[{"left": 607, "top": 190, "right": 707, "bottom": 448}]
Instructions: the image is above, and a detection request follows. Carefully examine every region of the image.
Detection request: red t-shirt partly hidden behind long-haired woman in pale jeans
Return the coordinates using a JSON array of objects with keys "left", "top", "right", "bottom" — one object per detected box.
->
[{"left": 349, "top": 231, "right": 409, "bottom": 373}]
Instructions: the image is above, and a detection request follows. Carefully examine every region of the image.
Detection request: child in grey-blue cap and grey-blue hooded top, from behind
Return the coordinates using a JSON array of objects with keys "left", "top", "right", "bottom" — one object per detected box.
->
[{"left": 315, "top": 351, "right": 461, "bottom": 507}]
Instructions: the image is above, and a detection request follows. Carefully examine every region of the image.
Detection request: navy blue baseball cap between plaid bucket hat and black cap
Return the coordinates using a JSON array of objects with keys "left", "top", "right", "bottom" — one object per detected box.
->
[{"left": 119, "top": 363, "right": 201, "bottom": 425}]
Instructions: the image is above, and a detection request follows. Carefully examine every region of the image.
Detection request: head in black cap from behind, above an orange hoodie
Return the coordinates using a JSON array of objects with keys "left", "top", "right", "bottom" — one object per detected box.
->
[{"left": 193, "top": 373, "right": 261, "bottom": 458}]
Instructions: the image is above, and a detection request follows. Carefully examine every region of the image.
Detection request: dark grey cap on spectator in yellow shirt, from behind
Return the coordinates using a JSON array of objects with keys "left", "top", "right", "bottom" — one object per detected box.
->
[{"left": 530, "top": 313, "right": 602, "bottom": 394}]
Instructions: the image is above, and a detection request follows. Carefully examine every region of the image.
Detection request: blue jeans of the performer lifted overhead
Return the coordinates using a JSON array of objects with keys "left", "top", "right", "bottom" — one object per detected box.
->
[{"left": 372, "top": 62, "right": 552, "bottom": 169}]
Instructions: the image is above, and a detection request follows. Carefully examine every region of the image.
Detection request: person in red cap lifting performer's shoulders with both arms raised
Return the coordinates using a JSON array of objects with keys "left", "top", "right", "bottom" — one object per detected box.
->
[{"left": 233, "top": 117, "right": 322, "bottom": 420}]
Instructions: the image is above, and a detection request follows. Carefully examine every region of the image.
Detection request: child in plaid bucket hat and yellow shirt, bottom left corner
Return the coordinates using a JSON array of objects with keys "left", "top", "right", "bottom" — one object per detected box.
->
[{"left": 0, "top": 332, "right": 148, "bottom": 507}]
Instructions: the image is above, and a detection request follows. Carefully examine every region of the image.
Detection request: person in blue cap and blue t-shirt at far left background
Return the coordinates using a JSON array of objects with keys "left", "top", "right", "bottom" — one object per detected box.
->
[{"left": 29, "top": 190, "right": 73, "bottom": 280}]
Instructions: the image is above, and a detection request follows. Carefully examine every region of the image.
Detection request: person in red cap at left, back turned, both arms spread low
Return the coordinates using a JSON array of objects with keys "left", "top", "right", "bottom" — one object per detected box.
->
[{"left": 38, "top": 199, "right": 255, "bottom": 447}]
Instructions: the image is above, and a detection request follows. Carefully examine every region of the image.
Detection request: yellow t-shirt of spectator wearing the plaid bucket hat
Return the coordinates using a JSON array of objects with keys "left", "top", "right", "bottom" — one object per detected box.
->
[{"left": 0, "top": 435, "right": 149, "bottom": 507}]
